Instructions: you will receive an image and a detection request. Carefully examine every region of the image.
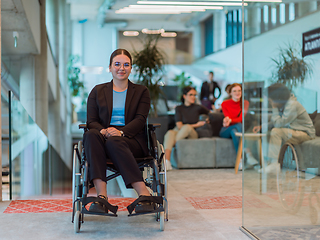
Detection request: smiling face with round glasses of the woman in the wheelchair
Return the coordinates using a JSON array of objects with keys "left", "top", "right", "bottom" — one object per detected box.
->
[{"left": 109, "top": 54, "right": 131, "bottom": 81}]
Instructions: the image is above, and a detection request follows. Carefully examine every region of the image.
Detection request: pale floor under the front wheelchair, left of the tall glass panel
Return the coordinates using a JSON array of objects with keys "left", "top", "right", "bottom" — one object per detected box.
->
[{"left": 0, "top": 169, "right": 249, "bottom": 240}]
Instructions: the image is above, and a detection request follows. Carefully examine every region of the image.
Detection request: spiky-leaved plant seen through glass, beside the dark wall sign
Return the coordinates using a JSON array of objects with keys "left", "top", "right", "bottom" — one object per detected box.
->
[{"left": 271, "top": 44, "right": 312, "bottom": 89}]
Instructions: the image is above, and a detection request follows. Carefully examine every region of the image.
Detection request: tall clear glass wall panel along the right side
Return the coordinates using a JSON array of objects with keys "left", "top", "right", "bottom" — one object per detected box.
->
[{"left": 242, "top": 1, "right": 320, "bottom": 239}]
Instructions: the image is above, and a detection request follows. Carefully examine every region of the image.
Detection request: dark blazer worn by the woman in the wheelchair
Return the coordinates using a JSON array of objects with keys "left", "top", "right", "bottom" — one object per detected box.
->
[{"left": 87, "top": 80, "right": 150, "bottom": 154}]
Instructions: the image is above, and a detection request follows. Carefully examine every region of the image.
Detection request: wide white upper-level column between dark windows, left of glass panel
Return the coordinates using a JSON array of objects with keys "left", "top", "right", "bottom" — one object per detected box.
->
[{"left": 213, "top": 11, "right": 227, "bottom": 52}]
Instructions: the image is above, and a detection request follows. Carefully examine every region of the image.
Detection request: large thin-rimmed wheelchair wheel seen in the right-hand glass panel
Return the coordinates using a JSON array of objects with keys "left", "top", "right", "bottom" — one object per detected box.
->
[{"left": 277, "top": 142, "right": 304, "bottom": 214}]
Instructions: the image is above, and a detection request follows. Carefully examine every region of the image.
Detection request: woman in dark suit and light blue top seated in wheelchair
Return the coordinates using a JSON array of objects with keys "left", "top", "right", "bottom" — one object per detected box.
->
[{"left": 83, "top": 49, "right": 155, "bottom": 213}]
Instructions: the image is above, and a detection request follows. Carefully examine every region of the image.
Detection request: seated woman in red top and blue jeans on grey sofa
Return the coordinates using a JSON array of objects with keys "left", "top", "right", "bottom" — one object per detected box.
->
[{"left": 219, "top": 83, "right": 249, "bottom": 152}]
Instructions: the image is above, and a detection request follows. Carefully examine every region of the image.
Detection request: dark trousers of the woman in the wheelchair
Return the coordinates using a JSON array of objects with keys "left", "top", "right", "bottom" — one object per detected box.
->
[{"left": 83, "top": 129, "right": 144, "bottom": 188}]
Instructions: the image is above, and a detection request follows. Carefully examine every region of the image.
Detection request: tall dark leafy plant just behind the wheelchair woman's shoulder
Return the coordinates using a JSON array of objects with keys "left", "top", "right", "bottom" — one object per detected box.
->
[{"left": 133, "top": 35, "right": 166, "bottom": 117}]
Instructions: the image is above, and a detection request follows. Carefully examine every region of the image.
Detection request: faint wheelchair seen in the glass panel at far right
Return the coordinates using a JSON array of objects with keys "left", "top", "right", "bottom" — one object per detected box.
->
[{"left": 277, "top": 141, "right": 320, "bottom": 224}]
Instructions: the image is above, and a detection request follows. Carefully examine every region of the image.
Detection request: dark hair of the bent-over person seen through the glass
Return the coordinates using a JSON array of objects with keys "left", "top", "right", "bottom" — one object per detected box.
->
[{"left": 267, "top": 83, "right": 291, "bottom": 106}]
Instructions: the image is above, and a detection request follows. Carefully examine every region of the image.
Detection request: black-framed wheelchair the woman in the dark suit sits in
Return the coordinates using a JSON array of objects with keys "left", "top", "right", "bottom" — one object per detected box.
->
[{"left": 72, "top": 124, "right": 168, "bottom": 233}]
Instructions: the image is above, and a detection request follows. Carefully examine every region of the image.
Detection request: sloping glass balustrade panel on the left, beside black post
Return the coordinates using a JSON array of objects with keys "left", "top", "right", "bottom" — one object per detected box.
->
[{"left": 8, "top": 92, "right": 71, "bottom": 200}]
